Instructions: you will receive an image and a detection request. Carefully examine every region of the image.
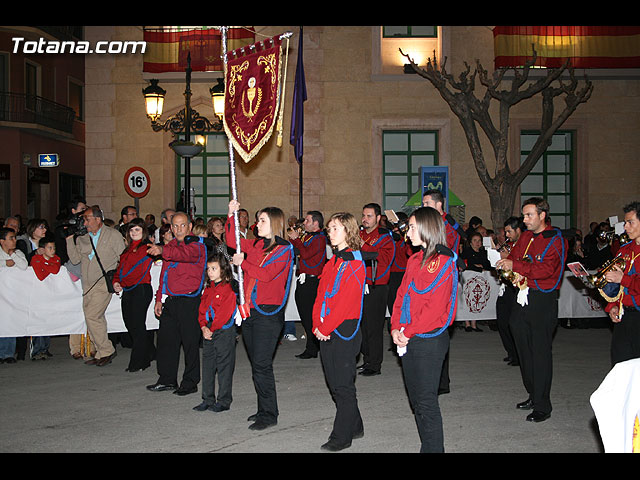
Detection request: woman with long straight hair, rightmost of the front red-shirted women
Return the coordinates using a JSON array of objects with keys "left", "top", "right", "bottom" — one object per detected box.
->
[{"left": 391, "top": 207, "right": 458, "bottom": 452}]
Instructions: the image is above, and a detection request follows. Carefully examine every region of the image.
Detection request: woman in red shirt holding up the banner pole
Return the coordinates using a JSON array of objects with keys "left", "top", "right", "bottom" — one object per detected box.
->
[{"left": 225, "top": 200, "right": 294, "bottom": 430}]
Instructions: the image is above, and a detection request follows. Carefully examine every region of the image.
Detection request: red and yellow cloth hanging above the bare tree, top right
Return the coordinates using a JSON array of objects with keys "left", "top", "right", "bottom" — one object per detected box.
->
[{"left": 493, "top": 26, "right": 640, "bottom": 68}]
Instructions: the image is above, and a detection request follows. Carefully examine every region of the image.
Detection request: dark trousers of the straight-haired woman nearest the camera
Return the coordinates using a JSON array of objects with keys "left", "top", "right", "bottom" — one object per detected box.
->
[{"left": 400, "top": 331, "right": 449, "bottom": 453}]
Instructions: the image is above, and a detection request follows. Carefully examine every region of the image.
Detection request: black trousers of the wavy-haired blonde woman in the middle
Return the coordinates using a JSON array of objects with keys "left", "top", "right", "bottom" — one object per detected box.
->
[{"left": 320, "top": 319, "right": 364, "bottom": 444}]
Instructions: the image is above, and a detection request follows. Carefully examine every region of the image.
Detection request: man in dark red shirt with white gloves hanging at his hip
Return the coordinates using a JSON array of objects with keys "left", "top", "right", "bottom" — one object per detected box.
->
[{"left": 496, "top": 197, "right": 567, "bottom": 422}]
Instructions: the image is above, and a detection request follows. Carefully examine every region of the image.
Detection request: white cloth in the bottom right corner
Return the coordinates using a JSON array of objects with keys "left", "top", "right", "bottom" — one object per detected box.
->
[{"left": 590, "top": 358, "right": 640, "bottom": 453}]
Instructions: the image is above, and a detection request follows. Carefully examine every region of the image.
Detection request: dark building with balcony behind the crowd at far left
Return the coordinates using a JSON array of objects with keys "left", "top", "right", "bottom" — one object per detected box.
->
[{"left": 0, "top": 26, "right": 85, "bottom": 225}]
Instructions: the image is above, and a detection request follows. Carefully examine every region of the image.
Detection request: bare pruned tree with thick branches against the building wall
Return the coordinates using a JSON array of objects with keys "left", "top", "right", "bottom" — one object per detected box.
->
[{"left": 400, "top": 48, "right": 593, "bottom": 229}]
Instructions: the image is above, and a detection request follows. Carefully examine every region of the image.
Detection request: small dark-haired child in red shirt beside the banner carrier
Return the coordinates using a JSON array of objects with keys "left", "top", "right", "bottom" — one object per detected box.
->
[{"left": 193, "top": 252, "right": 236, "bottom": 412}]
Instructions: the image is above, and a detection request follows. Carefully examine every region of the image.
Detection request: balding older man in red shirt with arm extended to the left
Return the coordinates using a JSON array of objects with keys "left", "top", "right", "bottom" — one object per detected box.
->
[{"left": 147, "top": 212, "right": 207, "bottom": 396}]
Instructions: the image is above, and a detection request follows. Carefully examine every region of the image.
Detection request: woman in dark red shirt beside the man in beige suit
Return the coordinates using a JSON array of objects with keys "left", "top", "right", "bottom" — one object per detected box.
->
[{"left": 113, "top": 218, "right": 156, "bottom": 372}]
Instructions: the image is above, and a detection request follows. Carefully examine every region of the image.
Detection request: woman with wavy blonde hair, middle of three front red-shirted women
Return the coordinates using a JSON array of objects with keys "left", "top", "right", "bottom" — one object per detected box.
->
[{"left": 312, "top": 213, "right": 366, "bottom": 451}]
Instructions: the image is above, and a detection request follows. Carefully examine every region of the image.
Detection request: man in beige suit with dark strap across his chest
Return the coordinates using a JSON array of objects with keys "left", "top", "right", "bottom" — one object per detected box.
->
[{"left": 67, "top": 205, "right": 125, "bottom": 367}]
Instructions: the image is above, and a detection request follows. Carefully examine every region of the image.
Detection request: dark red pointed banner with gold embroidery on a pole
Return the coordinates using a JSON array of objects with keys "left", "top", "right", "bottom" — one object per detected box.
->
[{"left": 223, "top": 37, "right": 282, "bottom": 162}]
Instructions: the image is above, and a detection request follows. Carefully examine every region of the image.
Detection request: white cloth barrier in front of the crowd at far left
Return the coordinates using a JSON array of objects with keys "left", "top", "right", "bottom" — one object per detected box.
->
[{"left": 0, "top": 263, "right": 162, "bottom": 337}]
